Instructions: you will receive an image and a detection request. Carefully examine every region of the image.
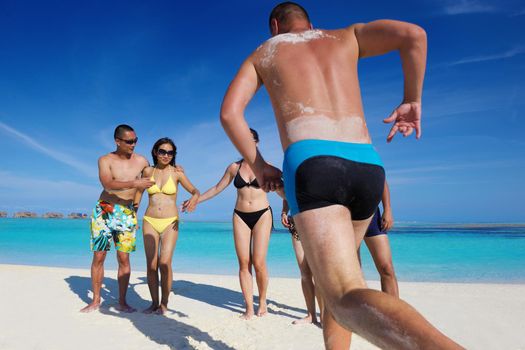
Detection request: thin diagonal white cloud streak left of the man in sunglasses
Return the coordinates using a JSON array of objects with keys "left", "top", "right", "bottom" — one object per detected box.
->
[{"left": 0, "top": 122, "right": 97, "bottom": 177}]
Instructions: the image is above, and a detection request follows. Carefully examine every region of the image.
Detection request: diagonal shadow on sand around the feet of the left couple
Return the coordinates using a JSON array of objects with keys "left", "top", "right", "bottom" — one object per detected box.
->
[{"left": 65, "top": 276, "right": 233, "bottom": 350}]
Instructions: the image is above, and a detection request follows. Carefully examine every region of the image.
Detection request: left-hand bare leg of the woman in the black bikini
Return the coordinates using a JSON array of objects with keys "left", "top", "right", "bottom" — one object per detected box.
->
[{"left": 233, "top": 214, "right": 254, "bottom": 320}]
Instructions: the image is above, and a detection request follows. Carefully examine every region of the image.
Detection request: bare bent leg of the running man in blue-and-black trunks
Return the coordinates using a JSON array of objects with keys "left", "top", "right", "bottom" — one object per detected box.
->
[{"left": 294, "top": 205, "right": 461, "bottom": 349}]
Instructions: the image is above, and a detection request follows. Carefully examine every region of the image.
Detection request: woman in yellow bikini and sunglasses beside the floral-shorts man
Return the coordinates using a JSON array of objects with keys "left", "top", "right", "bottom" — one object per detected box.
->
[{"left": 142, "top": 137, "right": 200, "bottom": 314}]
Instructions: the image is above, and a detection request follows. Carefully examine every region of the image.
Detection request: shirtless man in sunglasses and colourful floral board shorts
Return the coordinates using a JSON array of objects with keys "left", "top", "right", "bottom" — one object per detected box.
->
[{"left": 80, "top": 125, "right": 154, "bottom": 312}]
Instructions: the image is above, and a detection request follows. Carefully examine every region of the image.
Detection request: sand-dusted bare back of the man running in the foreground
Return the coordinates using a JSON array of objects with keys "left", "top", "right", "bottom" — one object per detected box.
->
[{"left": 249, "top": 27, "right": 370, "bottom": 149}]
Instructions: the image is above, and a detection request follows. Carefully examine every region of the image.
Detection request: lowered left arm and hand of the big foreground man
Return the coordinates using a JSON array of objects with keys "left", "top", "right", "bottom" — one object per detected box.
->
[{"left": 221, "top": 58, "right": 281, "bottom": 191}]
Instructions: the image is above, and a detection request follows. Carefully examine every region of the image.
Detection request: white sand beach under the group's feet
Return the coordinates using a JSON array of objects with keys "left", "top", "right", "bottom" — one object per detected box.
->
[{"left": 0, "top": 265, "right": 525, "bottom": 350}]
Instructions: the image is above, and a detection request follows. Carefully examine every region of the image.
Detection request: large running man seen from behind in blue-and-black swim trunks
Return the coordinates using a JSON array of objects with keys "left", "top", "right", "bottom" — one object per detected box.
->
[{"left": 221, "top": 2, "right": 460, "bottom": 349}]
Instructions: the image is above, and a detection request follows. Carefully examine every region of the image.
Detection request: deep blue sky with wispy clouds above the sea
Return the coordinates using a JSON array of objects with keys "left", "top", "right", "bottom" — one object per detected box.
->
[{"left": 0, "top": 0, "right": 525, "bottom": 222}]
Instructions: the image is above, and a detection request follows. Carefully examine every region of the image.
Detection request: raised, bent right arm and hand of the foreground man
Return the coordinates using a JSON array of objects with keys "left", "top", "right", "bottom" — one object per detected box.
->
[{"left": 349, "top": 20, "right": 427, "bottom": 142}]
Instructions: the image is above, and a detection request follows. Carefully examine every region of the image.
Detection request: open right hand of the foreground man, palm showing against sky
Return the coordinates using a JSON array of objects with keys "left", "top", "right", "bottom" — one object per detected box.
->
[{"left": 383, "top": 102, "right": 421, "bottom": 142}]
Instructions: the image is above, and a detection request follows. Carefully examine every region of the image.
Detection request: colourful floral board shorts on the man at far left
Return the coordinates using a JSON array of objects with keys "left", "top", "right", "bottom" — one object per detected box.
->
[{"left": 91, "top": 201, "right": 138, "bottom": 253}]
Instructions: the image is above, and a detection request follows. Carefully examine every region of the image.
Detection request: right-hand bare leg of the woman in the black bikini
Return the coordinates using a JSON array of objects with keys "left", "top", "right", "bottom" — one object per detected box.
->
[{"left": 252, "top": 210, "right": 272, "bottom": 316}]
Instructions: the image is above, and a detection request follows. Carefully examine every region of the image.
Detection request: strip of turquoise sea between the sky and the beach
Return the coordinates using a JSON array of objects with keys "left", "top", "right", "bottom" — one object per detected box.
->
[{"left": 0, "top": 218, "right": 525, "bottom": 283}]
